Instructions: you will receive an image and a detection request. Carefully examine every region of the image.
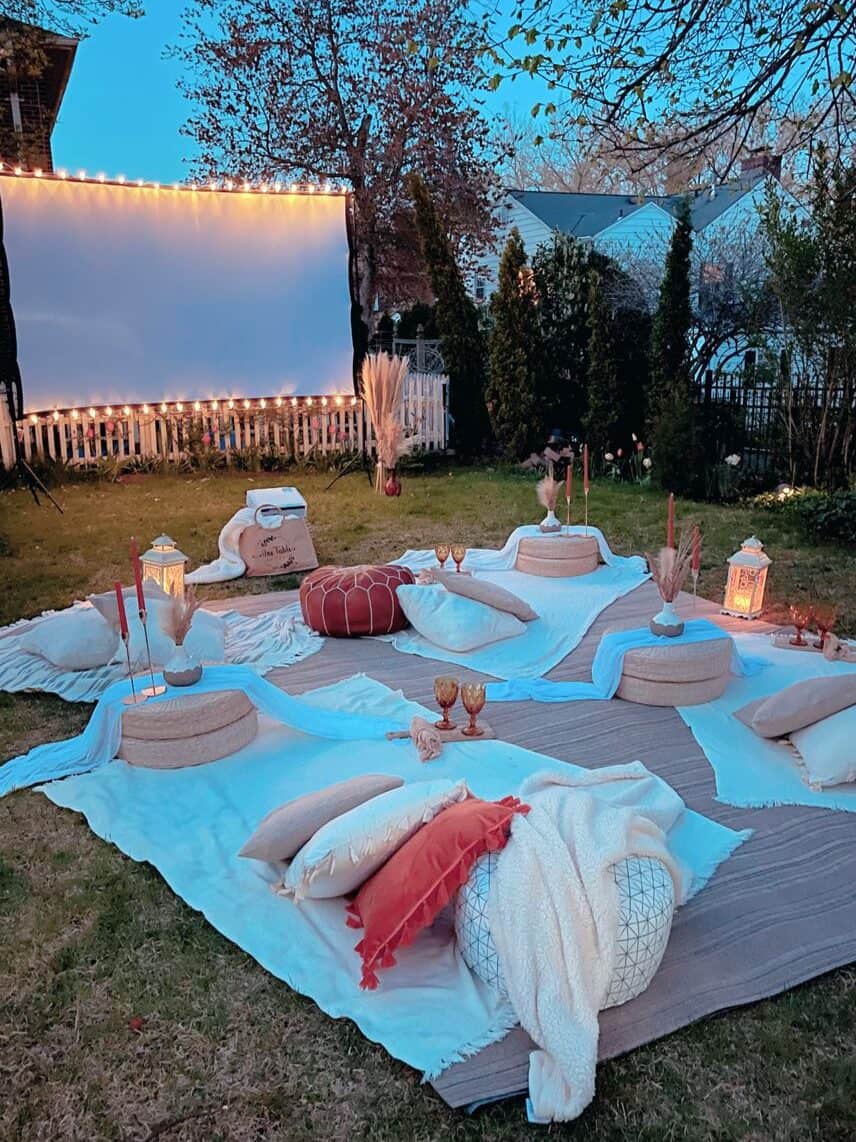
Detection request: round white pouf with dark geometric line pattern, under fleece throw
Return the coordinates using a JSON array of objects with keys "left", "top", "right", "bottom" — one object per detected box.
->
[{"left": 454, "top": 853, "right": 675, "bottom": 1007}]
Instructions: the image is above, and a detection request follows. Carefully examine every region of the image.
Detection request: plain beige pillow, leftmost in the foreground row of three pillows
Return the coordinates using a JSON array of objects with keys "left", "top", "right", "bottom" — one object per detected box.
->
[{"left": 237, "top": 773, "right": 404, "bottom": 861}]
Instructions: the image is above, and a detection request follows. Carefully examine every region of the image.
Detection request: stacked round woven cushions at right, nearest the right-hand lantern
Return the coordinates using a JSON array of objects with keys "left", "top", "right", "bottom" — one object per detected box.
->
[{"left": 616, "top": 634, "right": 732, "bottom": 706}]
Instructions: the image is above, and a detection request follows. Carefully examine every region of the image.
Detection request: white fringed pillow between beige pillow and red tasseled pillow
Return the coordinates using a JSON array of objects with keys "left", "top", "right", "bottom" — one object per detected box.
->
[{"left": 282, "top": 779, "right": 467, "bottom": 901}]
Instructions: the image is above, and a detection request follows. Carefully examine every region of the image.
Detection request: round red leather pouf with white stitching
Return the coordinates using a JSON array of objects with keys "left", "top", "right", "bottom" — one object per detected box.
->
[{"left": 300, "top": 563, "right": 415, "bottom": 638}]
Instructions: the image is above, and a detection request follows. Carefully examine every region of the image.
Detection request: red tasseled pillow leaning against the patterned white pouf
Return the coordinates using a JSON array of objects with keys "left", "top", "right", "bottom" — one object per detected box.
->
[{"left": 347, "top": 797, "right": 530, "bottom": 990}]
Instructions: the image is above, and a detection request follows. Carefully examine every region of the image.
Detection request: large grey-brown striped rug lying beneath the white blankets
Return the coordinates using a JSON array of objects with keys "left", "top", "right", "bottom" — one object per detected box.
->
[{"left": 204, "top": 584, "right": 856, "bottom": 1107}]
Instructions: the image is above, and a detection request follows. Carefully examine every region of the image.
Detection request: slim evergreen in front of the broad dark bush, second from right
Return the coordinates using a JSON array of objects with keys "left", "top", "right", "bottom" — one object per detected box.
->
[{"left": 583, "top": 271, "right": 622, "bottom": 458}]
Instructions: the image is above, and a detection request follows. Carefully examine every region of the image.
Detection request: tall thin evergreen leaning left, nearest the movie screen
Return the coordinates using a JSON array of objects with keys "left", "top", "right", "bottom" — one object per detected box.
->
[{"left": 407, "top": 175, "right": 488, "bottom": 456}]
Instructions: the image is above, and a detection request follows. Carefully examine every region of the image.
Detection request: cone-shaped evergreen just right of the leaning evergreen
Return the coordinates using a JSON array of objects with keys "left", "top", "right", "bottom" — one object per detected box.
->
[{"left": 487, "top": 227, "right": 544, "bottom": 459}]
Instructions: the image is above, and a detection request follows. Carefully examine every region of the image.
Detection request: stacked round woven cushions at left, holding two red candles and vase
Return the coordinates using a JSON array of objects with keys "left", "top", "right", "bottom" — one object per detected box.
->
[{"left": 116, "top": 690, "right": 258, "bottom": 769}]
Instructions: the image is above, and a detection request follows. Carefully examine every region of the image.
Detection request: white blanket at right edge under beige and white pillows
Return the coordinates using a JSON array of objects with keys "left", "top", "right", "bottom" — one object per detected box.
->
[{"left": 678, "top": 634, "right": 856, "bottom": 813}]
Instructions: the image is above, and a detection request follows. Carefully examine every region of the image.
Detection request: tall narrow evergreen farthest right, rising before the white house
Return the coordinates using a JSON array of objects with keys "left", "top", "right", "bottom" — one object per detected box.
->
[{"left": 649, "top": 207, "right": 704, "bottom": 494}]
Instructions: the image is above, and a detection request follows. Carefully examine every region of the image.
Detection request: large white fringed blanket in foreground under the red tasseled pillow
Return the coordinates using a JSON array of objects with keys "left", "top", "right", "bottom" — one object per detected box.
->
[{"left": 0, "top": 667, "right": 746, "bottom": 1091}]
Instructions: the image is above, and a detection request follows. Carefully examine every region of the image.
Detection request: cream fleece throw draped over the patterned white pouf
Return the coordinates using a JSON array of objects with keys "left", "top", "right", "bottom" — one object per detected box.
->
[{"left": 488, "top": 762, "right": 689, "bottom": 1121}]
